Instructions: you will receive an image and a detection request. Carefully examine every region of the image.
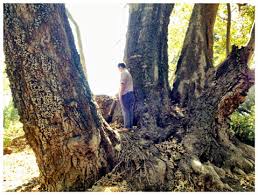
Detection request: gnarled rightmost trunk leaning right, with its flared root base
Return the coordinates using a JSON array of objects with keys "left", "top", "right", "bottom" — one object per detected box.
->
[{"left": 179, "top": 24, "right": 255, "bottom": 180}]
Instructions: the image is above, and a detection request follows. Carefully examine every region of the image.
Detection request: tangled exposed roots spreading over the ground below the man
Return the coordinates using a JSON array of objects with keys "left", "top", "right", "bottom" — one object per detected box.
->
[{"left": 89, "top": 126, "right": 254, "bottom": 191}]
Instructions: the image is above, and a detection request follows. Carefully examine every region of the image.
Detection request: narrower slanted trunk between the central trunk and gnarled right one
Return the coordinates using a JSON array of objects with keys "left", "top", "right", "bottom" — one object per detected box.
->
[{"left": 171, "top": 4, "right": 218, "bottom": 106}]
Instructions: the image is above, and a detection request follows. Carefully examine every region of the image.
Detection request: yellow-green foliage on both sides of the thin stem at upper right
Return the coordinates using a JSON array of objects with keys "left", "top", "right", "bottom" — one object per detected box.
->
[{"left": 213, "top": 3, "right": 255, "bottom": 66}]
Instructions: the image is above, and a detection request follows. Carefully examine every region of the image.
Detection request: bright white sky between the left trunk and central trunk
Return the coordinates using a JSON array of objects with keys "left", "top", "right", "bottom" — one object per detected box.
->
[{"left": 66, "top": 2, "right": 128, "bottom": 95}]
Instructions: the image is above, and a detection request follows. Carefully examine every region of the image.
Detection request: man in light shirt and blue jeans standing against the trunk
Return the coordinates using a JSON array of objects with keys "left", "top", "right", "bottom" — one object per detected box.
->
[{"left": 118, "top": 63, "right": 135, "bottom": 131}]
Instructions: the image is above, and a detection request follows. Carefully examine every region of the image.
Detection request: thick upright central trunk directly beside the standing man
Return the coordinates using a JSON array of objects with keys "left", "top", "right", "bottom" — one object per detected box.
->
[{"left": 124, "top": 4, "right": 174, "bottom": 128}]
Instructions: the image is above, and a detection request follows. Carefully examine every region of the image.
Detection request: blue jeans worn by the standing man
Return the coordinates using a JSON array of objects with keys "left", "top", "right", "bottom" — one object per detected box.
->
[{"left": 121, "top": 91, "right": 135, "bottom": 128}]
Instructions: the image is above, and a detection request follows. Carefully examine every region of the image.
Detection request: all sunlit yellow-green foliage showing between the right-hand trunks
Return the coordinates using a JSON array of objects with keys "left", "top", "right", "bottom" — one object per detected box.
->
[{"left": 168, "top": 3, "right": 255, "bottom": 85}]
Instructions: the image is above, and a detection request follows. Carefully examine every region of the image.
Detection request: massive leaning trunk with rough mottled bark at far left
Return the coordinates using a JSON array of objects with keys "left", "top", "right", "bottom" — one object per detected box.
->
[{"left": 4, "top": 4, "right": 119, "bottom": 191}]
